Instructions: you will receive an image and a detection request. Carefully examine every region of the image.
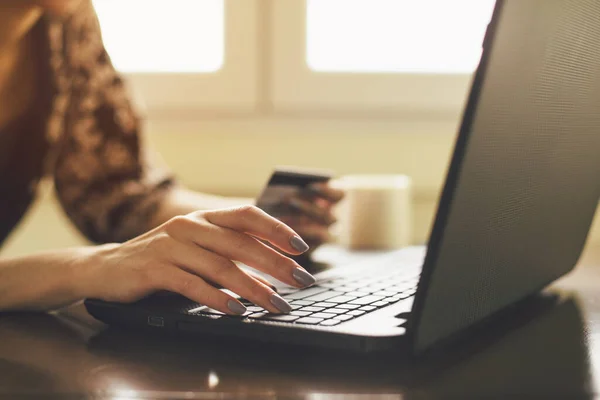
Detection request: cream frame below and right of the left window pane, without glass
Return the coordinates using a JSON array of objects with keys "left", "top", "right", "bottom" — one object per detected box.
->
[{"left": 112, "top": 0, "right": 261, "bottom": 119}]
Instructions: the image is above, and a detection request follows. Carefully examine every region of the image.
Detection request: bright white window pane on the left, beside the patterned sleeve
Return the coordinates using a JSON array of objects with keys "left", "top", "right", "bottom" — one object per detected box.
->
[{"left": 94, "top": 0, "right": 225, "bottom": 72}]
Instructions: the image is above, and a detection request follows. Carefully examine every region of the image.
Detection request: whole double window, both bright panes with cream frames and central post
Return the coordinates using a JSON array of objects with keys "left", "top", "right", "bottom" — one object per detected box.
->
[{"left": 94, "top": 0, "right": 495, "bottom": 118}]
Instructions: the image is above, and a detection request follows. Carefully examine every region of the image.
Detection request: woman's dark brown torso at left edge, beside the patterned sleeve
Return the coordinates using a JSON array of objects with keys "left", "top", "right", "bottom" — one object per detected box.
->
[{"left": 0, "top": 20, "right": 54, "bottom": 244}]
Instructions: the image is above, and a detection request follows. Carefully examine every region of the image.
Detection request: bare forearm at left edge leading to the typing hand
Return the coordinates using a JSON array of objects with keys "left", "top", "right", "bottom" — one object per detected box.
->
[{"left": 0, "top": 247, "right": 95, "bottom": 312}]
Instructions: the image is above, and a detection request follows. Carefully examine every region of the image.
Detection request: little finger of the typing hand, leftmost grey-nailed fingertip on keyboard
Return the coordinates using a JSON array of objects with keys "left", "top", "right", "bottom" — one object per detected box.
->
[{"left": 156, "top": 268, "right": 246, "bottom": 315}]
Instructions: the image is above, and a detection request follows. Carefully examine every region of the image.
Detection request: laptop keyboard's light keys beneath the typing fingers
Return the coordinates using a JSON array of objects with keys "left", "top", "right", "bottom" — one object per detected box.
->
[{"left": 187, "top": 269, "right": 420, "bottom": 326}]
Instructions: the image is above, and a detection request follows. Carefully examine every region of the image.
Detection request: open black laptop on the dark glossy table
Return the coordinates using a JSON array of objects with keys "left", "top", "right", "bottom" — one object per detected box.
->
[{"left": 85, "top": 0, "right": 600, "bottom": 355}]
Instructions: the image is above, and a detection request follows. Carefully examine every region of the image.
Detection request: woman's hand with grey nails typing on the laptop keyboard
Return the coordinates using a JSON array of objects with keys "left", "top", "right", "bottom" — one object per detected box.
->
[{"left": 86, "top": 206, "right": 315, "bottom": 315}]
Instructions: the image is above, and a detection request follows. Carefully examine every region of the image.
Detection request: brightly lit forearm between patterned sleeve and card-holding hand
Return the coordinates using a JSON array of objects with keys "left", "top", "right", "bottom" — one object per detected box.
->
[{"left": 151, "top": 188, "right": 253, "bottom": 227}]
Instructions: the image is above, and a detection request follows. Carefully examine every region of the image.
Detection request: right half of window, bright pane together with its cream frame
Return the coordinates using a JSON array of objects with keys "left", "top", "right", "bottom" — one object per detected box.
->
[{"left": 270, "top": 0, "right": 495, "bottom": 118}]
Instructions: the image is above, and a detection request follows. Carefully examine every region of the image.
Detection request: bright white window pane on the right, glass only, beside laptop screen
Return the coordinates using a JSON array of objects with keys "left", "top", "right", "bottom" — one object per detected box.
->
[{"left": 306, "top": 0, "right": 494, "bottom": 73}]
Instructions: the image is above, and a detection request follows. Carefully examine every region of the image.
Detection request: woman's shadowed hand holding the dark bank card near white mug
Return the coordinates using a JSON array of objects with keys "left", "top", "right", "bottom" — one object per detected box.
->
[{"left": 258, "top": 183, "right": 344, "bottom": 256}]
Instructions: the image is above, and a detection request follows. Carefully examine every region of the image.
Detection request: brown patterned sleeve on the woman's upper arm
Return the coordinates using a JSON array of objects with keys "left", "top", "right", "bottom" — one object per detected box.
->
[{"left": 54, "top": 0, "right": 174, "bottom": 243}]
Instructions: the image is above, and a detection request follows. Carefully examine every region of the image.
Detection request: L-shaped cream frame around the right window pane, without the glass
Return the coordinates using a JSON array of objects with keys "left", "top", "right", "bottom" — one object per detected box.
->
[{"left": 269, "top": 0, "right": 480, "bottom": 119}]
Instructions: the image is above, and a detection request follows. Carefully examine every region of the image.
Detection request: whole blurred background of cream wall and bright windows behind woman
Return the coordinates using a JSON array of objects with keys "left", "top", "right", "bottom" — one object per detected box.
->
[{"left": 3, "top": 0, "right": 600, "bottom": 255}]
